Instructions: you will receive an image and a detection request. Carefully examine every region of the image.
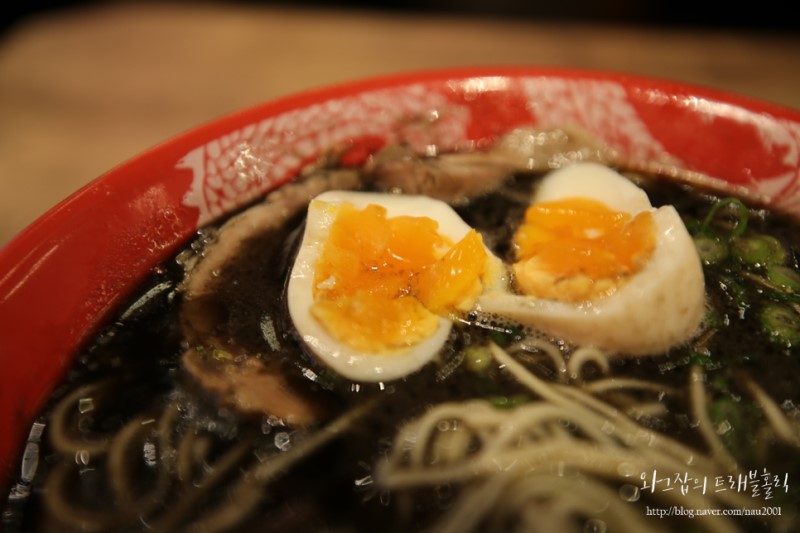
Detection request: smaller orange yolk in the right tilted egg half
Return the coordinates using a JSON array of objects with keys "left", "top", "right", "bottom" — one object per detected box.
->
[{"left": 513, "top": 197, "right": 656, "bottom": 302}]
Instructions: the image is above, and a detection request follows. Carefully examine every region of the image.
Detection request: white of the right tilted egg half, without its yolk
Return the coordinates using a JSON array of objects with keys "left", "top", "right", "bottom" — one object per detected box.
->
[{"left": 477, "top": 163, "right": 705, "bottom": 355}]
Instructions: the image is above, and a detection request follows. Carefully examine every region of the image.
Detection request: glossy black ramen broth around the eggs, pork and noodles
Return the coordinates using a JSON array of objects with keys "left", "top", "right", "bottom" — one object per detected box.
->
[{"left": 3, "top": 167, "right": 800, "bottom": 532}]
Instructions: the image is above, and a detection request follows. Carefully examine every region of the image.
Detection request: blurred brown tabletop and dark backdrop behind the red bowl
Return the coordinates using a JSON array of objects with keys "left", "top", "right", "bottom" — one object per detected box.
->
[{"left": 0, "top": 0, "right": 800, "bottom": 246}]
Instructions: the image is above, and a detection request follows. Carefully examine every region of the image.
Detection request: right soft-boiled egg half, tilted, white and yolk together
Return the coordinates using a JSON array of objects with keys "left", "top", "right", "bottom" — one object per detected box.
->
[{"left": 478, "top": 163, "right": 705, "bottom": 355}]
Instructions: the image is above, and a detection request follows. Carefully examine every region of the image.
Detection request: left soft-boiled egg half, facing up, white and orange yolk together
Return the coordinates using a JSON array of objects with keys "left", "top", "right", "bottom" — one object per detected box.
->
[{"left": 287, "top": 191, "right": 504, "bottom": 382}]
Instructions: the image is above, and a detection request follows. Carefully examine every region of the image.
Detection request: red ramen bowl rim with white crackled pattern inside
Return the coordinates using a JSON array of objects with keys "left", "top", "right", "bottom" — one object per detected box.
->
[{"left": 0, "top": 68, "right": 800, "bottom": 493}]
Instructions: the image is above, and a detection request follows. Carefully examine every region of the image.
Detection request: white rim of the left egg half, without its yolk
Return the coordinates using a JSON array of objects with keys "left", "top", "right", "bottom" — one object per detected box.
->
[{"left": 287, "top": 191, "right": 503, "bottom": 382}]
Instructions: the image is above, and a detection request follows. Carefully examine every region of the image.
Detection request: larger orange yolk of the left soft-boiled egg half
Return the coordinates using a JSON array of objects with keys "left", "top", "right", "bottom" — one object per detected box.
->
[{"left": 311, "top": 204, "right": 487, "bottom": 352}]
